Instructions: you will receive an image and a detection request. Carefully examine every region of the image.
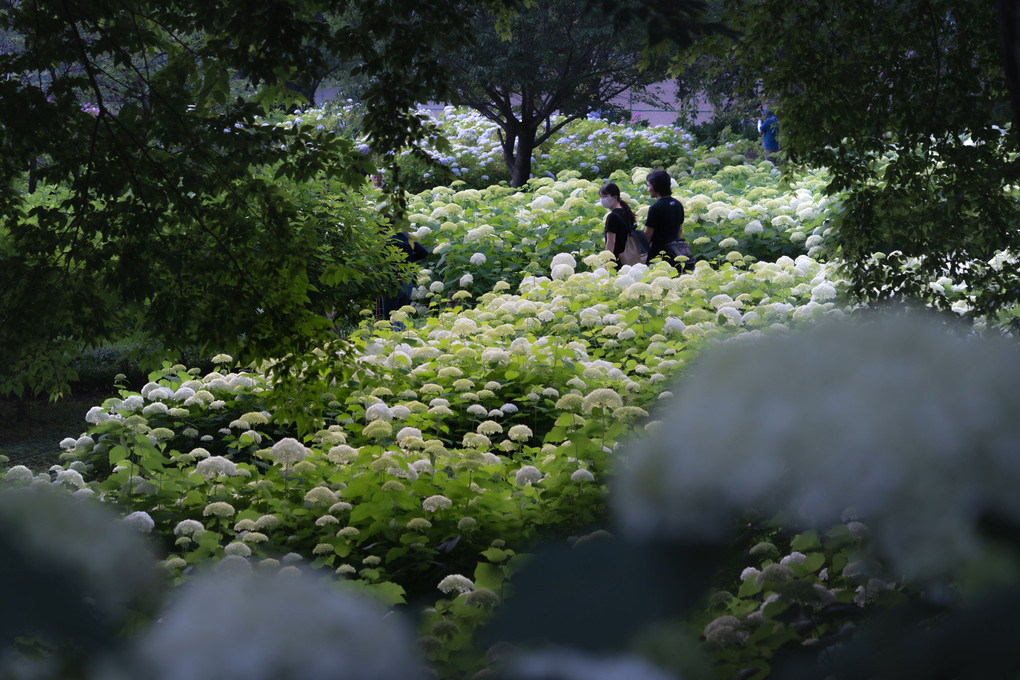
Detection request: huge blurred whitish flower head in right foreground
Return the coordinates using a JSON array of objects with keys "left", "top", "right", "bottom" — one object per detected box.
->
[{"left": 612, "top": 315, "right": 1020, "bottom": 578}]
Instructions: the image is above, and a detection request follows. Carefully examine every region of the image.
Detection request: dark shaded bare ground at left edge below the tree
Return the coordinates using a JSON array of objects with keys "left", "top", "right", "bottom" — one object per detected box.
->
[{"left": 0, "top": 394, "right": 103, "bottom": 470}]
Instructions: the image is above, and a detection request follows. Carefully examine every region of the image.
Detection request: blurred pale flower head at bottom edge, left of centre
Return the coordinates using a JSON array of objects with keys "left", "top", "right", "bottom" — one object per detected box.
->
[{"left": 137, "top": 570, "right": 425, "bottom": 680}]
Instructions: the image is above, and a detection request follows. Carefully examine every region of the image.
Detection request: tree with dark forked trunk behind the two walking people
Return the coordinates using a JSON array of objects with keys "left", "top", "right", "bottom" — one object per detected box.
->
[{"left": 446, "top": 0, "right": 704, "bottom": 187}]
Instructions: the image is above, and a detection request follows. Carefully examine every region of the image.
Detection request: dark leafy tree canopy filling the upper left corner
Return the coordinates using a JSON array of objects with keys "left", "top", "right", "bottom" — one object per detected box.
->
[{"left": 0, "top": 0, "right": 505, "bottom": 409}]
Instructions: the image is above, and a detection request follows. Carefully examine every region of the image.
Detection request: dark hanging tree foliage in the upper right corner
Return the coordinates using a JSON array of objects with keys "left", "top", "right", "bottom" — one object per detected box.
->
[{"left": 714, "top": 0, "right": 1020, "bottom": 322}]
